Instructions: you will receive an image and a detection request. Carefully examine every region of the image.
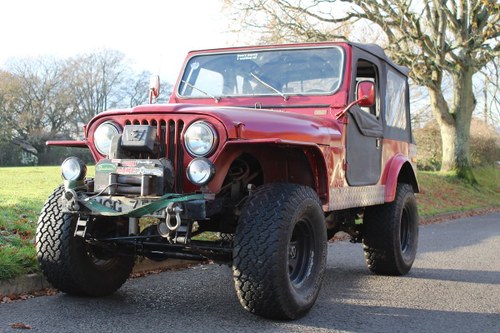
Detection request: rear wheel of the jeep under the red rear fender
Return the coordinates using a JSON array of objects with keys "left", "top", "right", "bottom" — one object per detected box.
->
[{"left": 363, "top": 183, "right": 418, "bottom": 275}]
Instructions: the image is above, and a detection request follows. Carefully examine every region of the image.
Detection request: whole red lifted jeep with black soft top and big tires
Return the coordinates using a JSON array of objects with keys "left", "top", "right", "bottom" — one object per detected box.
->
[{"left": 36, "top": 43, "right": 418, "bottom": 319}]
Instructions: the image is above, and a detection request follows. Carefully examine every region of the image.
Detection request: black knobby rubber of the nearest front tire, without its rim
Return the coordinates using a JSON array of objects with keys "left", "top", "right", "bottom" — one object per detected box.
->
[{"left": 233, "top": 184, "right": 326, "bottom": 319}]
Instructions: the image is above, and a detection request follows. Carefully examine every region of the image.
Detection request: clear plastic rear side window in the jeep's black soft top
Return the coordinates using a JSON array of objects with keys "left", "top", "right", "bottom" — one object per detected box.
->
[{"left": 385, "top": 69, "right": 407, "bottom": 130}]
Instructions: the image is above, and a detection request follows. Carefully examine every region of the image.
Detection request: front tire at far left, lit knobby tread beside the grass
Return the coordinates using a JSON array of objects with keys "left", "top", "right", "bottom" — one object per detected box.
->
[{"left": 36, "top": 186, "right": 135, "bottom": 296}]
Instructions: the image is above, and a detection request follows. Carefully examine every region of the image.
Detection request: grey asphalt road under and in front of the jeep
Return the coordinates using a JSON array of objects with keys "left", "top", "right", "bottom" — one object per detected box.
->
[{"left": 0, "top": 213, "right": 500, "bottom": 333}]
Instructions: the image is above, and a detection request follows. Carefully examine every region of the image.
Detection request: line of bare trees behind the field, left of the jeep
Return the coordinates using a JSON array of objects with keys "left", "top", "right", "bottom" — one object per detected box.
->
[{"left": 0, "top": 50, "right": 176, "bottom": 165}]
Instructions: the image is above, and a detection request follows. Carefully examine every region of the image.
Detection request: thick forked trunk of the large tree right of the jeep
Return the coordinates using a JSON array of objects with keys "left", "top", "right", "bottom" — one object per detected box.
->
[{"left": 429, "top": 70, "right": 477, "bottom": 184}]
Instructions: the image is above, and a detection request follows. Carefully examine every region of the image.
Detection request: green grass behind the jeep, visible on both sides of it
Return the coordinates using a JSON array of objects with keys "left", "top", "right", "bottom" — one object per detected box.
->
[{"left": 0, "top": 167, "right": 500, "bottom": 280}]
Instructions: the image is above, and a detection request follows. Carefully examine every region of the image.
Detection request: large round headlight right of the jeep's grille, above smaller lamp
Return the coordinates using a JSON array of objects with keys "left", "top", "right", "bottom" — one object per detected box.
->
[{"left": 184, "top": 121, "right": 217, "bottom": 157}]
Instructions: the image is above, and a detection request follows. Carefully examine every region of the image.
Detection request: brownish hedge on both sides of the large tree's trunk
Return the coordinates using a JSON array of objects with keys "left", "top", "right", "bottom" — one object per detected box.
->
[{"left": 414, "top": 119, "right": 500, "bottom": 171}]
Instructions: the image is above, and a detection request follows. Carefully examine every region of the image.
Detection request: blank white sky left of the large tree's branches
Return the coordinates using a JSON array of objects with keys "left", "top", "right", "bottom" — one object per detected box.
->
[{"left": 0, "top": 0, "right": 237, "bottom": 83}]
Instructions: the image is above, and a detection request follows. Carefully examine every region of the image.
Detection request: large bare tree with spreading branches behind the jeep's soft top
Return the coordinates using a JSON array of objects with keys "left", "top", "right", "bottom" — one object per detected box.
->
[{"left": 226, "top": 0, "right": 500, "bottom": 183}]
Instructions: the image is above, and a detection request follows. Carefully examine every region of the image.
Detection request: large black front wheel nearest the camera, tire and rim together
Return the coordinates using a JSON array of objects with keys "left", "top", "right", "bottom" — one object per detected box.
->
[{"left": 233, "top": 184, "right": 327, "bottom": 319}]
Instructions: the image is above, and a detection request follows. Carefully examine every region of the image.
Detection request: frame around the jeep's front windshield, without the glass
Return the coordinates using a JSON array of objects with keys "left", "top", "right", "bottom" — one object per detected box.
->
[{"left": 175, "top": 45, "right": 346, "bottom": 101}]
